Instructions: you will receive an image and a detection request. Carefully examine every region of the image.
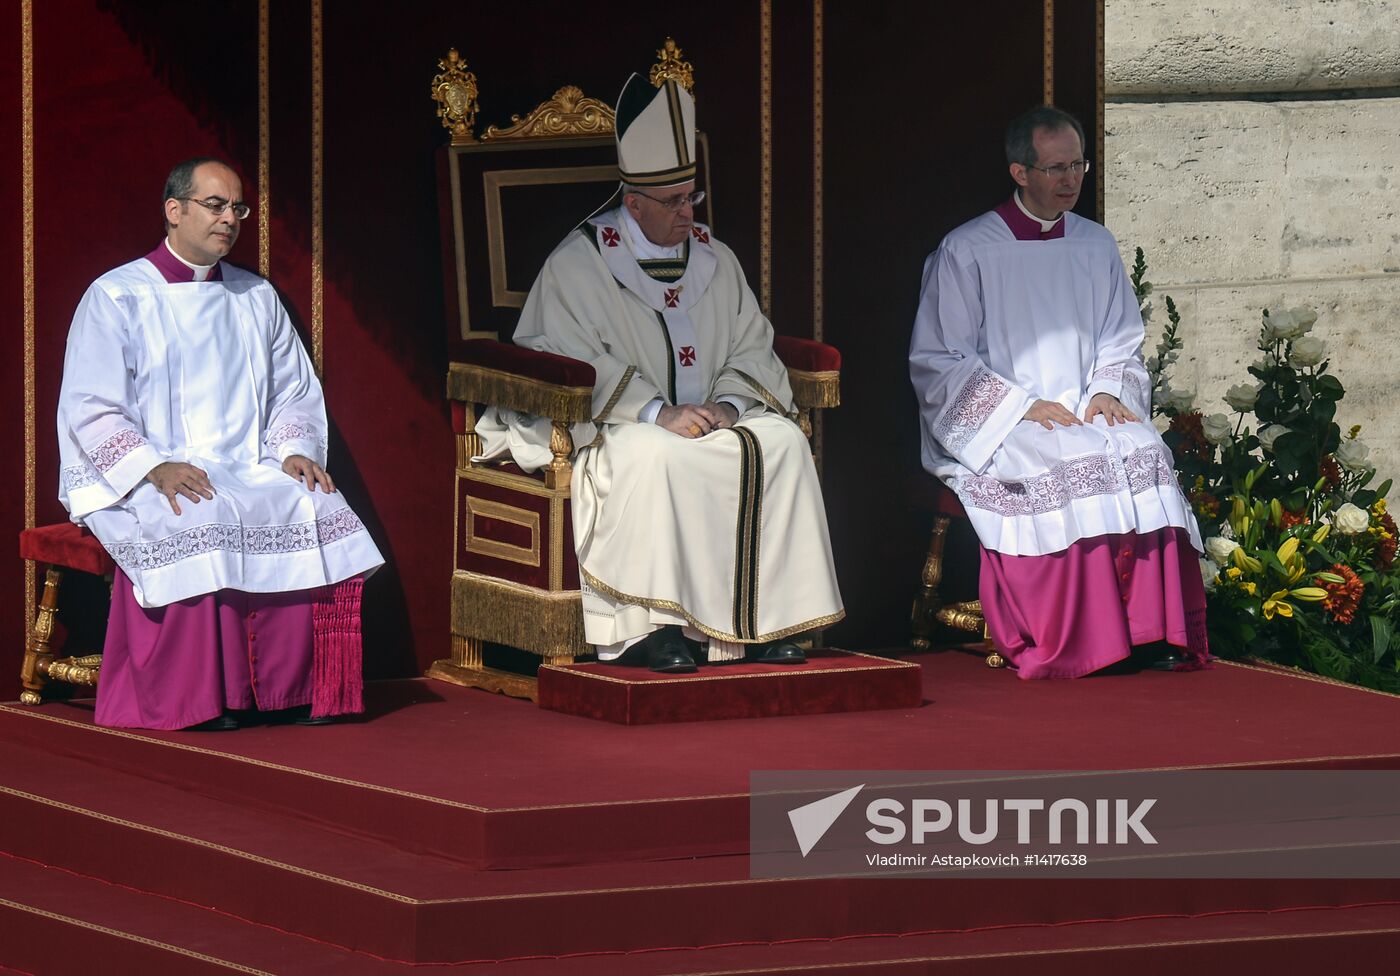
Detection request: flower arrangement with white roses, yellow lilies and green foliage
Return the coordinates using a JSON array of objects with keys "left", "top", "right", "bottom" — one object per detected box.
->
[{"left": 1131, "top": 248, "right": 1400, "bottom": 692}]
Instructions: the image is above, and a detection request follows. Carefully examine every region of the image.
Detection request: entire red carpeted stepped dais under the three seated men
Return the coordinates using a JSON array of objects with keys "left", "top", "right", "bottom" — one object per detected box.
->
[{"left": 0, "top": 653, "right": 1400, "bottom": 973}]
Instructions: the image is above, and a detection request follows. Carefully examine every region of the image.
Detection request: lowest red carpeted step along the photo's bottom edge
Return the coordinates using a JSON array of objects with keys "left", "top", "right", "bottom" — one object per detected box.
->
[{"left": 8, "top": 857, "right": 1400, "bottom": 976}]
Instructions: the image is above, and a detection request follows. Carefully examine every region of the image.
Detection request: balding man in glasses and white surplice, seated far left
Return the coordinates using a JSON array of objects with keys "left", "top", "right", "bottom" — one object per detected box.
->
[{"left": 57, "top": 158, "right": 384, "bottom": 731}]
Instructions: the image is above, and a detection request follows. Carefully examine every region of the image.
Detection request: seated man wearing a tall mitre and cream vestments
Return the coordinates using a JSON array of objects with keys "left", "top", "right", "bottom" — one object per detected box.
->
[{"left": 477, "top": 76, "right": 844, "bottom": 672}]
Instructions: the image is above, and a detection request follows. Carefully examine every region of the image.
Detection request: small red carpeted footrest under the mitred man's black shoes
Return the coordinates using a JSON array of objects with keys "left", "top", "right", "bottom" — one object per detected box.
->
[{"left": 539, "top": 648, "right": 923, "bottom": 725}]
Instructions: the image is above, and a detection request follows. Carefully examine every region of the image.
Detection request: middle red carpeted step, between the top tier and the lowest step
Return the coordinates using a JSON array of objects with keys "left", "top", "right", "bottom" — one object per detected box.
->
[{"left": 8, "top": 744, "right": 1400, "bottom": 962}]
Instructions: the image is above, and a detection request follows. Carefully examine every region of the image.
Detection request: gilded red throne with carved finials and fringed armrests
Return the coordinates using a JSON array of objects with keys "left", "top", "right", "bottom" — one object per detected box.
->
[{"left": 427, "top": 38, "right": 840, "bottom": 697}]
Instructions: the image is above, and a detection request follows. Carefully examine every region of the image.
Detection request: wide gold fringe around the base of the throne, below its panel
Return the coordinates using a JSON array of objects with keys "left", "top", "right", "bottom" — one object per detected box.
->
[{"left": 452, "top": 570, "right": 588, "bottom": 657}]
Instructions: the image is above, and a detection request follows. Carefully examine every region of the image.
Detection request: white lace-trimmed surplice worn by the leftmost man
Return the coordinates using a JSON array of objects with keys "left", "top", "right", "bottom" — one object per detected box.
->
[{"left": 57, "top": 258, "right": 384, "bottom": 608}]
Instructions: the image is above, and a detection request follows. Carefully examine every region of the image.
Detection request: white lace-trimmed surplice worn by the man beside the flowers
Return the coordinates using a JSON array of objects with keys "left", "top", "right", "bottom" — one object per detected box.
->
[{"left": 910, "top": 200, "right": 1201, "bottom": 556}]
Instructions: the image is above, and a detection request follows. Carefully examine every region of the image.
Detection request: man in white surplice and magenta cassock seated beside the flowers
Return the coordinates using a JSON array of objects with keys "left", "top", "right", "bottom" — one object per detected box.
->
[{"left": 909, "top": 106, "right": 1207, "bottom": 678}]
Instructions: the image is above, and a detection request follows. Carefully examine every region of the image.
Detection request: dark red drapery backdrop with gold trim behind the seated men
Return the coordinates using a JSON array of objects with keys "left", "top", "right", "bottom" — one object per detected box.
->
[{"left": 0, "top": 0, "right": 1099, "bottom": 699}]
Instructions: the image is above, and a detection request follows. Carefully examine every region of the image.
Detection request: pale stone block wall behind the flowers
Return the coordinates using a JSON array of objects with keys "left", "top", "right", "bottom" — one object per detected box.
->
[{"left": 1103, "top": 0, "right": 1400, "bottom": 480}]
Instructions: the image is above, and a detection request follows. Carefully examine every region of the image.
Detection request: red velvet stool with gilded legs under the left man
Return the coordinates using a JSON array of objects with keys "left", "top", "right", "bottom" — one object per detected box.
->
[{"left": 20, "top": 522, "right": 116, "bottom": 704}]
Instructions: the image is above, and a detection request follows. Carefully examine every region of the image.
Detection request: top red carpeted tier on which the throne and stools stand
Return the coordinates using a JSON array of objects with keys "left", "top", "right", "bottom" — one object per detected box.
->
[{"left": 8, "top": 654, "right": 1400, "bottom": 867}]
